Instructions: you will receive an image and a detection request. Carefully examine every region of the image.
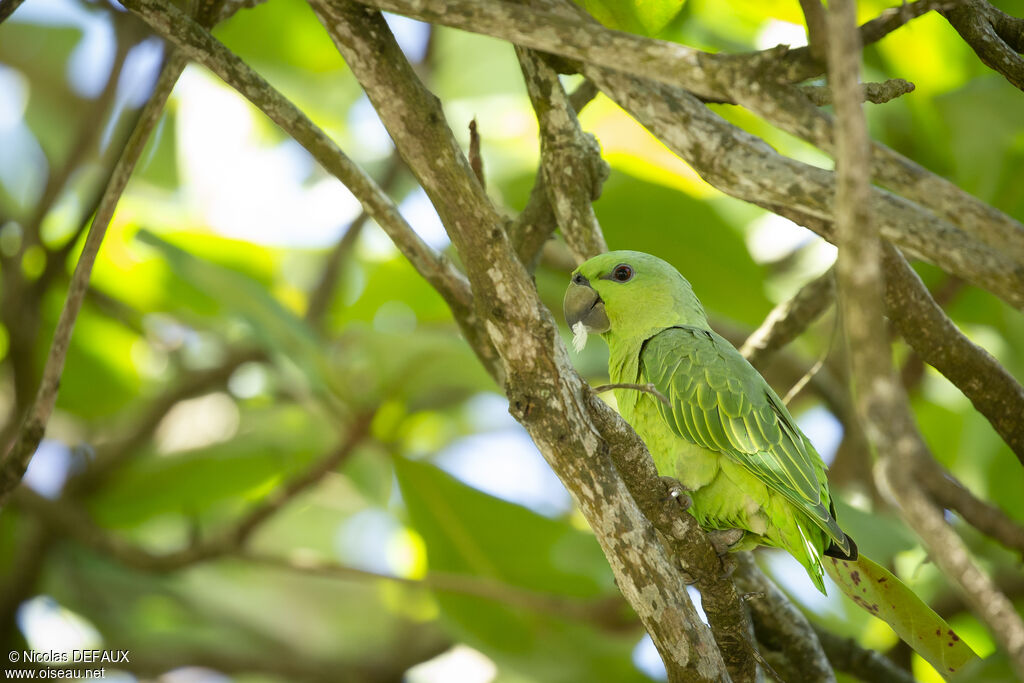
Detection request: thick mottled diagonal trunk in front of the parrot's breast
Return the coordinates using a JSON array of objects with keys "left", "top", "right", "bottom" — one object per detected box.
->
[{"left": 313, "top": 0, "right": 741, "bottom": 680}]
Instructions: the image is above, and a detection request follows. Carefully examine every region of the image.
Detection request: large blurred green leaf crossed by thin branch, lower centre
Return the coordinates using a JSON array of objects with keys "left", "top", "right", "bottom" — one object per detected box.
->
[{"left": 395, "top": 458, "right": 645, "bottom": 681}]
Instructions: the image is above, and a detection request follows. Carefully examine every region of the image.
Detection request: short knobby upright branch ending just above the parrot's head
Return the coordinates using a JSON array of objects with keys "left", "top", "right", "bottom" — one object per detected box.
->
[{"left": 516, "top": 47, "right": 608, "bottom": 263}]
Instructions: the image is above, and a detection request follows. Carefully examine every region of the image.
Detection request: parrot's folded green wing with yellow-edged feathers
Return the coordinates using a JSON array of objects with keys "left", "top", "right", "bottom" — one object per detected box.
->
[{"left": 640, "top": 326, "right": 850, "bottom": 552}]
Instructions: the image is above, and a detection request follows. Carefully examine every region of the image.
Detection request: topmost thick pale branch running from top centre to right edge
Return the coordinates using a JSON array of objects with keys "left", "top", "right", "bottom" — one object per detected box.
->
[{"left": 358, "top": 0, "right": 1024, "bottom": 278}]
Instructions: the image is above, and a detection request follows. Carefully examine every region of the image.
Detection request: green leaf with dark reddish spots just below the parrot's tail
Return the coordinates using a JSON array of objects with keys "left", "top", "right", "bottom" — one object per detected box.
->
[{"left": 824, "top": 554, "right": 978, "bottom": 676}]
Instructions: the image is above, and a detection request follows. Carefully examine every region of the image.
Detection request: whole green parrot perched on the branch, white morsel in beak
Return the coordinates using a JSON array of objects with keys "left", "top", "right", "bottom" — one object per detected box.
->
[{"left": 564, "top": 251, "right": 857, "bottom": 593}]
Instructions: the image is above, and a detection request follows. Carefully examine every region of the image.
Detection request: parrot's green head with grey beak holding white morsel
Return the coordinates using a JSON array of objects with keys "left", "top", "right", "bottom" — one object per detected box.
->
[{"left": 562, "top": 251, "right": 708, "bottom": 351}]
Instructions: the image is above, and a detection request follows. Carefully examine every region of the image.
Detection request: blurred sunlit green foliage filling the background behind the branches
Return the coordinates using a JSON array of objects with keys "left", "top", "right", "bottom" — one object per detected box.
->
[{"left": 0, "top": 0, "right": 1024, "bottom": 681}]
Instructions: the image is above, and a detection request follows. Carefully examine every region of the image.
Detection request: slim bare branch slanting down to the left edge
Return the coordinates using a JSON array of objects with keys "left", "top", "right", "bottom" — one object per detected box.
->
[{"left": 0, "top": 50, "right": 185, "bottom": 506}]
